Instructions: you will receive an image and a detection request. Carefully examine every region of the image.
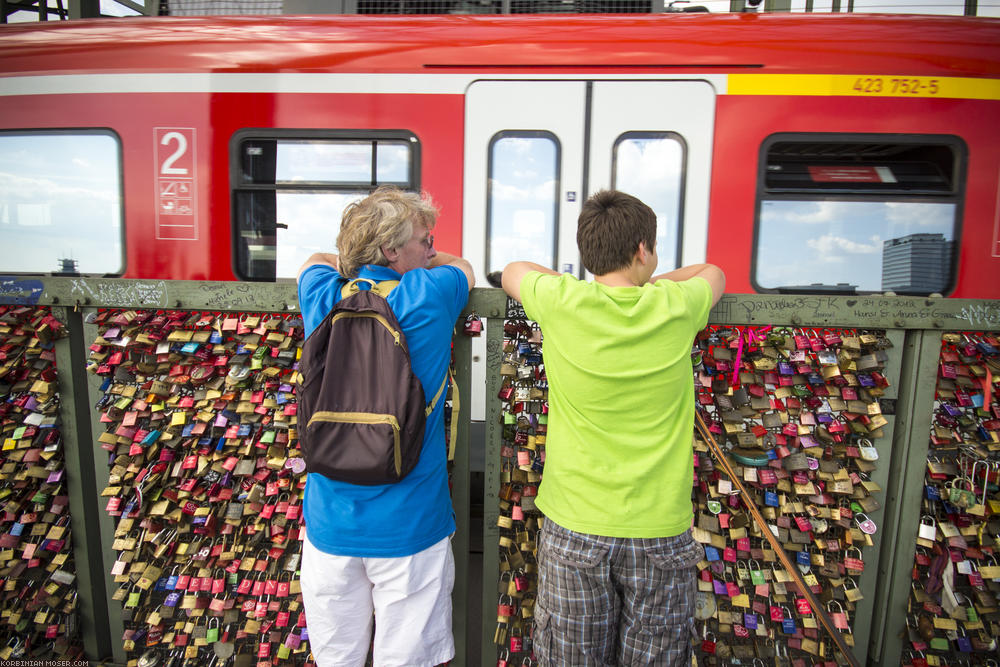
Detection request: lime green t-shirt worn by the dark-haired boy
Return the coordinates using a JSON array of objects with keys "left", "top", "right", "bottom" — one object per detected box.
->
[{"left": 521, "top": 272, "right": 712, "bottom": 537}]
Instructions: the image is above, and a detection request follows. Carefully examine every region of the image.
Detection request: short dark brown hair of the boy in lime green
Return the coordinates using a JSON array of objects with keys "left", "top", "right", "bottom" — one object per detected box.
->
[{"left": 576, "top": 190, "right": 656, "bottom": 276}]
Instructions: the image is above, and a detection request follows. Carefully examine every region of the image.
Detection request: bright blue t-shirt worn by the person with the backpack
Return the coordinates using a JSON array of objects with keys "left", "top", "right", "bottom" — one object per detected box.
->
[{"left": 298, "top": 264, "right": 469, "bottom": 558}]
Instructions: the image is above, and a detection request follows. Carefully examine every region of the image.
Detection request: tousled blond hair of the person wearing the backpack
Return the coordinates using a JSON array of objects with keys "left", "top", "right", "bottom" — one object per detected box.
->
[{"left": 337, "top": 185, "right": 438, "bottom": 278}]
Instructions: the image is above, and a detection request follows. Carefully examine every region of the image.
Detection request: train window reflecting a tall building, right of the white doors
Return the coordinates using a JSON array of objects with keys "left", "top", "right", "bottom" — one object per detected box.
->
[{"left": 752, "top": 134, "right": 966, "bottom": 295}]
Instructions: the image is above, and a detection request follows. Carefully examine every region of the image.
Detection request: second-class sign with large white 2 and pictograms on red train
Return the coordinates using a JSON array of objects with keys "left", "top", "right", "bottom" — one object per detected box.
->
[{"left": 153, "top": 127, "right": 198, "bottom": 241}]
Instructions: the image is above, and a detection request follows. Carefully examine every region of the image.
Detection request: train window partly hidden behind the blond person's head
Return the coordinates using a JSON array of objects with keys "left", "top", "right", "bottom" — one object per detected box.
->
[{"left": 232, "top": 130, "right": 420, "bottom": 281}]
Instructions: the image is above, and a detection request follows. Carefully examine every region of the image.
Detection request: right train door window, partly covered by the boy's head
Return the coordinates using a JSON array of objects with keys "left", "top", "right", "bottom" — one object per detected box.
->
[{"left": 611, "top": 132, "right": 685, "bottom": 273}]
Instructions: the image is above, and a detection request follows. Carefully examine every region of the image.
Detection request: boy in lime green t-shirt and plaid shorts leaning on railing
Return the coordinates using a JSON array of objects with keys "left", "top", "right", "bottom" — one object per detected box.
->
[{"left": 502, "top": 191, "right": 725, "bottom": 666}]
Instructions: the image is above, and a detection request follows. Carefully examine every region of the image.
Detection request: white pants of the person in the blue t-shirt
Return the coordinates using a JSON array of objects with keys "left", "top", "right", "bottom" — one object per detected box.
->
[{"left": 301, "top": 535, "right": 455, "bottom": 667}]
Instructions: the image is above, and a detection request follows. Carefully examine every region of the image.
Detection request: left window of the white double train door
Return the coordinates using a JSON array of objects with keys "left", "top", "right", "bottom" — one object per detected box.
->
[{"left": 486, "top": 130, "right": 559, "bottom": 272}]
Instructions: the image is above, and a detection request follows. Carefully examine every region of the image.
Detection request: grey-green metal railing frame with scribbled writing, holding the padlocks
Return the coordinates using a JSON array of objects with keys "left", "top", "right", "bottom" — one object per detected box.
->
[{"left": 0, "top": 277, "right": 1000, "bottom": 666}]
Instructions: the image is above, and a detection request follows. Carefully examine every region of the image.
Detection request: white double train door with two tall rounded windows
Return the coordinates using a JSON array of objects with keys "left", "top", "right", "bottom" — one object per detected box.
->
[{"left": 462, "top": 80, "right": 715, "bottom": 420}]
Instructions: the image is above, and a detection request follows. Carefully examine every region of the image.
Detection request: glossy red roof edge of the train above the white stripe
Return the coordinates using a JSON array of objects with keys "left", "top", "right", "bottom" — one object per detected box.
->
[{"left": 0, "top": 13, "right": 1000, "bottom": 77}]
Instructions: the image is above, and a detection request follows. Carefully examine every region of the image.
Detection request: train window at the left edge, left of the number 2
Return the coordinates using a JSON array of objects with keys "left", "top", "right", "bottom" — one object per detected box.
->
[{"left": 0, "top": 130, "right": 125, "bottom": 275}]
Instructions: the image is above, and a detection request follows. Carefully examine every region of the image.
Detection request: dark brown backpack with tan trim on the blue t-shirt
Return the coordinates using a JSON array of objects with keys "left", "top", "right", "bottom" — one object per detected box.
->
[{"left": 298, "top": 279, "right": 448, "bottom": 485}]
